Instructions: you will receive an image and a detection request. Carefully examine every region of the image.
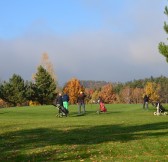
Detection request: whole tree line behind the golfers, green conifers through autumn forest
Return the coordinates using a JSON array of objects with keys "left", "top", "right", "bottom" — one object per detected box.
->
[{"left": 0, "top": 65, "right": 168, "bottom": 107}]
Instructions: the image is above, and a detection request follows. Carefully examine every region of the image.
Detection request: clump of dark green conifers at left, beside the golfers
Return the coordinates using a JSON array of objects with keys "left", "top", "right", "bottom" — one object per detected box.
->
[{"left": 0, "top": 66, "right": 56, "bottom": 106}]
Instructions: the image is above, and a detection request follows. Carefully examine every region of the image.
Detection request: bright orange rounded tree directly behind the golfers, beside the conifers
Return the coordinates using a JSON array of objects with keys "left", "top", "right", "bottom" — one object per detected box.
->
[{"left": 63, "top": 78, "right": 84, "bottom": 104}]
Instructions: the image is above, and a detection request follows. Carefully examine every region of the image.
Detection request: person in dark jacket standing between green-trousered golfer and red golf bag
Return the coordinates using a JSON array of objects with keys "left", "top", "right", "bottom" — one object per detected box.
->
[{"left": 77, "top": 91, "right": 86, "bottom": 115}]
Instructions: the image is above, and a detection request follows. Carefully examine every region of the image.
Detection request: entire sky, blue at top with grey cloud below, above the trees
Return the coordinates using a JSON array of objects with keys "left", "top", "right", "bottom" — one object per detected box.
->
[{"left": 0, "top": 0, "right": 168, "bottom": 84}]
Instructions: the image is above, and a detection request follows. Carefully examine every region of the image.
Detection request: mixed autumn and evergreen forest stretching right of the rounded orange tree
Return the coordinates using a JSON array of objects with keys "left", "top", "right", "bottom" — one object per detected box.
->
[{"left": 80, "top": 76, "right": 168, "bottom": 103}]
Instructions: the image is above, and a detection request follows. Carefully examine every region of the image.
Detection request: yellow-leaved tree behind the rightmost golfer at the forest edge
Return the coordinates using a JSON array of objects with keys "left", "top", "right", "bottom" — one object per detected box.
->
[{"left": 144, "top": 82, "right": 160, "bottom": 102}]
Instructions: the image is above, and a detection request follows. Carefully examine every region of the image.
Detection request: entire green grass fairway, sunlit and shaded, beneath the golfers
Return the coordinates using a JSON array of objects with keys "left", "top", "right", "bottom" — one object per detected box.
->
[{"left": 0, "top": 104, "right": 168, "bottom": 162}]
